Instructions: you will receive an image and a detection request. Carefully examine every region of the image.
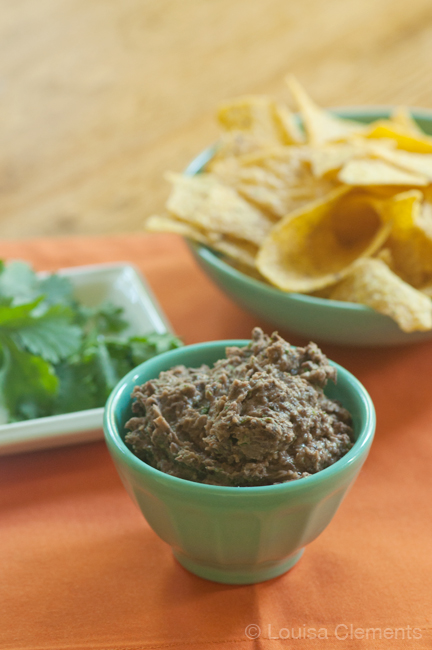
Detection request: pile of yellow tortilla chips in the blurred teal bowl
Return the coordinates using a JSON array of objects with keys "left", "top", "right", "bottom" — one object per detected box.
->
[{"left": 145, "top": 78, "right": 432, "bottom": 332}]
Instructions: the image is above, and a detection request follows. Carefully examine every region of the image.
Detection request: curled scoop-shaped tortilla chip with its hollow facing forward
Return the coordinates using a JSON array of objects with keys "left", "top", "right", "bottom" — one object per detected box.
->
[{"left": 256, "top": 187, "right": 391, "bottom": 293}]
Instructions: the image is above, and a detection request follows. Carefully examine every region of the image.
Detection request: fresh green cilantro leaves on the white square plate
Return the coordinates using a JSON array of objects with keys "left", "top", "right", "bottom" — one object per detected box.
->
[{"left": 0, "top": 261, "right": 181, "bottom": 422}]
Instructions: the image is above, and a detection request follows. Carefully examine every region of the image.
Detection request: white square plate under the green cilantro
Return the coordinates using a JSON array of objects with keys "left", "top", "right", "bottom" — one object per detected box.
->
[{"left": 0, "top": 263, "right": 172, "bottom": 455}]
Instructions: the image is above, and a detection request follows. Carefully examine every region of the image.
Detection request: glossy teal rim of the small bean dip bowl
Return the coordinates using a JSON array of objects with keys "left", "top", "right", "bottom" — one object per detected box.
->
[{"left": 104, "top": 339, "right": 376, "bottom": 496}]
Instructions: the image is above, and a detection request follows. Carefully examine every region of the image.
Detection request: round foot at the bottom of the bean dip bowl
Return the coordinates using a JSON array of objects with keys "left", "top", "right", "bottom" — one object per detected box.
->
[{"left": 173, "top": 548, "right": 304, "bottom": 585}]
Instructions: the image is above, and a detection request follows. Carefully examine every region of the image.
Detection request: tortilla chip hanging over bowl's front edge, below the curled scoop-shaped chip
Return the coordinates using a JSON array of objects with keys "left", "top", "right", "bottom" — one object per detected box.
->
[{"left": 330, "top": 258, "right": 432, "bottom": 332}]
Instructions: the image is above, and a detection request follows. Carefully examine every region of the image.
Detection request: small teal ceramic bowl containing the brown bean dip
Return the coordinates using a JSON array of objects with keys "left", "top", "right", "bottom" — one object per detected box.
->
[{"left": 104, "top": 340, "right": 375, "bottom": 584}]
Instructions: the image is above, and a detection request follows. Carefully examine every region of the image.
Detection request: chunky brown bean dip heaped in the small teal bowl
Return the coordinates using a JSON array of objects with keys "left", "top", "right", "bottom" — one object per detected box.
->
[{"left": 126, "top": 327, "right": 354, "bottom": 486}]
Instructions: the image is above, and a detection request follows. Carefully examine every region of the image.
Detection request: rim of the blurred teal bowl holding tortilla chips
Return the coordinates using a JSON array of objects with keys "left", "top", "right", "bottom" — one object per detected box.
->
[{"left": 183, "top": 105, "right": 432, "bottom": 316}]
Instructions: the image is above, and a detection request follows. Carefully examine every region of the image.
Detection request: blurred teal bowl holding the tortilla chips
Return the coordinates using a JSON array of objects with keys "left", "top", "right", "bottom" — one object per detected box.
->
[{"left": 185, "top": 108, "right": 432, "bottom": 346}]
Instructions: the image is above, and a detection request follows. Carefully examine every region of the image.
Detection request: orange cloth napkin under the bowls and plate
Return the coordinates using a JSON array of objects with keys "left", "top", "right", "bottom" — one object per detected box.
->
[{"left": 0, "top": 235, "right": 432, "bottom": 650}]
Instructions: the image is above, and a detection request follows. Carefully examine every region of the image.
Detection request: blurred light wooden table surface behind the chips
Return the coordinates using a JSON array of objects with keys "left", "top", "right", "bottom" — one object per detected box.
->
[{"left": 0, "top": 0, "right": 432, "bottom": 238}]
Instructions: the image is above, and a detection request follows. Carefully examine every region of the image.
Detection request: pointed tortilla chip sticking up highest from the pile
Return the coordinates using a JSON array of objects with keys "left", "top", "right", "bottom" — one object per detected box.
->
[{"left": 286, "top": 75, "right": 366, "bottom": 145}]
